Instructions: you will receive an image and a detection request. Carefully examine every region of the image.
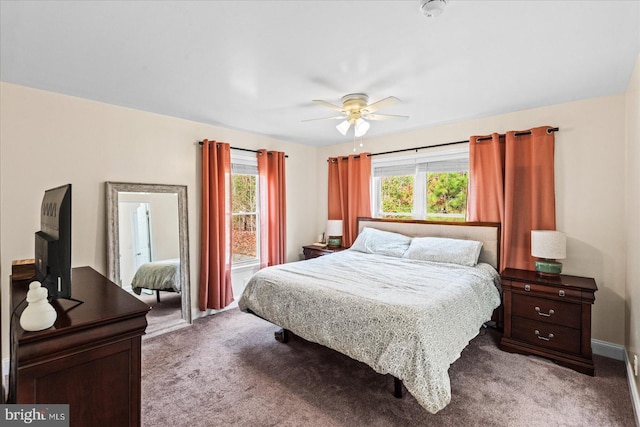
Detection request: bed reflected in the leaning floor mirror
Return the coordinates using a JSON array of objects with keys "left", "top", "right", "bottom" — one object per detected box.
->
[{"left": 131, "top": 258, "right": 181, "bottom": 302}]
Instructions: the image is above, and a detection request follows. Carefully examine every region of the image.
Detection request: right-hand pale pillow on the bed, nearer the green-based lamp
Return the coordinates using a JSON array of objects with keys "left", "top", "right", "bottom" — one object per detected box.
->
[{"left": 403, "top": 237, "right": 482, "bottom": 267}]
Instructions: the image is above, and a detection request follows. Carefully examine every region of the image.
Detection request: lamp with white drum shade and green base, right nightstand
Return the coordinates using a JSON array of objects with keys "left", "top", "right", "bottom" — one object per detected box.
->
[{"left": 531, "top": 230, "right": 567, "bottom": 277}]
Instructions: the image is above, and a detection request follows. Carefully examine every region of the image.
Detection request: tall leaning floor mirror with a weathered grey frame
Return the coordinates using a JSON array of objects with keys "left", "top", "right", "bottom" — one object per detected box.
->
[{"left": 106, "top": 182, "right": 191, "bottom": 336}]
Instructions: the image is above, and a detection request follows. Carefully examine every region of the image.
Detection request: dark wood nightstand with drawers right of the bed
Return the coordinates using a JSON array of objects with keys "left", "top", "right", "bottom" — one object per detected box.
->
[{"left": 500, "top": 268, "right": 598, "bottom": 375}]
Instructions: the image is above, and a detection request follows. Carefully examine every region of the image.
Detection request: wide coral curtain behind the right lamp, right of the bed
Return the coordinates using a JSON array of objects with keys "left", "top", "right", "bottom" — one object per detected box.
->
[{"left": 467, "top": 126, "right": 556, "bottom": 270}]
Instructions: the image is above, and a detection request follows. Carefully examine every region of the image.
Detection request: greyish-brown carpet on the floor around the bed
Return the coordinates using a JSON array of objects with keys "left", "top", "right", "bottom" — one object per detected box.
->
[{"left": 142, "top": 309, "right": 635, "bottom": 427}]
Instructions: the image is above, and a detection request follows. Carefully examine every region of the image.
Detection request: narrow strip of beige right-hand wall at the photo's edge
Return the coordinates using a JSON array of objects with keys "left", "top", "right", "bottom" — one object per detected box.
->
[{"left": 625, "top": 55, "right": 640, "bottom": 406}]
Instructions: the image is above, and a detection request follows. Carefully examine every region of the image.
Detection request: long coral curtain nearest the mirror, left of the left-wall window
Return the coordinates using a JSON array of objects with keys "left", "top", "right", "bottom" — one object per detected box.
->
[{"left": 199, "top": 139, "right": 233, "bottom": 311}]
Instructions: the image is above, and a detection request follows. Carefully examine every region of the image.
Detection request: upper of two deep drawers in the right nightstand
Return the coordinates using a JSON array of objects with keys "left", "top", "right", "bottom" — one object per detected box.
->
[{"left": 511, "top": 294, "right": 582, "bottom": 329}]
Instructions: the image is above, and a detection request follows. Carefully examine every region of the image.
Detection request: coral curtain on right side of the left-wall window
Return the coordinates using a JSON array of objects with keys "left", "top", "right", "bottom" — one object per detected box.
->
[{"left": 257, "top": 149, "right": 287, "bottom": 268}]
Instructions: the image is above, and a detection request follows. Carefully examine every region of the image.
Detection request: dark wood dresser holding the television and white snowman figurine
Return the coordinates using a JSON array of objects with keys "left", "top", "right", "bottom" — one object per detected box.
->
[{"left": 9, "top": 267, "right": 149, "bottom": 426}]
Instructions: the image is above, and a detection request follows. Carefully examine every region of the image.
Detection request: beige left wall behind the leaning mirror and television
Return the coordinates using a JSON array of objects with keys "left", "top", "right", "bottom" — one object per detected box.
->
[{"left": 0, "top": 83, "right": 317, "bottom": 358}]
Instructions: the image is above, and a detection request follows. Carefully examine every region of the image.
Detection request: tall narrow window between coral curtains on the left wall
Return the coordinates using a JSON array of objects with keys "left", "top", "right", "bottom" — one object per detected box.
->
[{"left": 231, "top": 155, "right": 260, "bottom": 266}]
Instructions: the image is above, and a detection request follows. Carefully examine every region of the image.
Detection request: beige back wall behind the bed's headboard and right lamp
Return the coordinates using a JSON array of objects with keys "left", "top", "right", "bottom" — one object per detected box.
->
[{"left": 315, "top": 94, "right": 626, "bottom": 345}]
